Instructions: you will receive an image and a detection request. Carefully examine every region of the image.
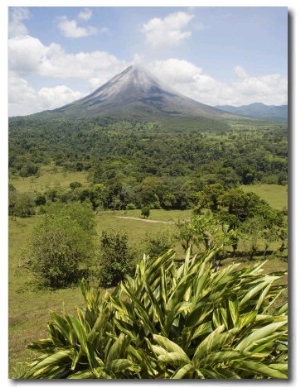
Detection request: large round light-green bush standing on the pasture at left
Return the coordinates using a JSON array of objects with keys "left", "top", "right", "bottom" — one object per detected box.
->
[{"left": 29, "top": 206, "right": 95, "bottom": 288}]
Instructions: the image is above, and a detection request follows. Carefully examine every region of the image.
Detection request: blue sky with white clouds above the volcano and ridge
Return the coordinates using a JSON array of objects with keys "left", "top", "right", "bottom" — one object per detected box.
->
[{"left": 8, "top": 5, "right": 288, "bottom": 116}]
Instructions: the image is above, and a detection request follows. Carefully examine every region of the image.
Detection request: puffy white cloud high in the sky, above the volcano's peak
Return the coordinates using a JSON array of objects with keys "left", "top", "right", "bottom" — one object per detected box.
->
[{"left": 142, "top": 12, "right": 194, "bottom": 47}]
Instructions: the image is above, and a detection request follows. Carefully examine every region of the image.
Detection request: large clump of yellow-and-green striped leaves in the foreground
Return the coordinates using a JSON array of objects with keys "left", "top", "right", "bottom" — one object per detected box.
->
[{"left": 23, "top": 250, "right": 288, "bottom": 379}]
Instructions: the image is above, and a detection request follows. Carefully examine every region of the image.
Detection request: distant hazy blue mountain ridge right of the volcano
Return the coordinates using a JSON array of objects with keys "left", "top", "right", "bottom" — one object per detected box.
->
[{"left": 215, "top": 102, "right": 288, "bottom": 121}]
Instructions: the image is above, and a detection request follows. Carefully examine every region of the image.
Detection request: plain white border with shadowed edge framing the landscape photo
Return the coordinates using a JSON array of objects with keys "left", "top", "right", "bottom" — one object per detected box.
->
[{"left": 0, "top": 0, "right": 300, "bottom": 386}]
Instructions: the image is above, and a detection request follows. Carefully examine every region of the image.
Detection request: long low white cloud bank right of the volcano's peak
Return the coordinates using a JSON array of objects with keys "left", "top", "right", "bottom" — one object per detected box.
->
[{"left": 149, "top": 58, "right": 287, "bottom": 106}]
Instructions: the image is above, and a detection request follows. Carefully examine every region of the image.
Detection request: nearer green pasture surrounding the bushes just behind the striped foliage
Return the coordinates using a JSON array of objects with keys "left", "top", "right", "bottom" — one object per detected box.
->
[{"left": 9, "top": 203, "right": 287, "bottom": 378}]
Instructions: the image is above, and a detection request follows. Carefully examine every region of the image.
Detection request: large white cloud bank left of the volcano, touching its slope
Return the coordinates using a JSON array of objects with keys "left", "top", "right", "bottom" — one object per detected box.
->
[{"left": 8, "top": 35, "right": 128, "bottom": 116}]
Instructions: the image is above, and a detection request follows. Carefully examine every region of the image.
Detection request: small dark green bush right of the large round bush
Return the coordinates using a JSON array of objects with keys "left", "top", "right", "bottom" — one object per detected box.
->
[{"left": 100, "top": 231, "right": 135, "bottom": 287}]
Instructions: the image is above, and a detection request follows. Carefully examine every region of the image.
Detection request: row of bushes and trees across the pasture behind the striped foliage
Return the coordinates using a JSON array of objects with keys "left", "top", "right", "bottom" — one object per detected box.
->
[{"left": 26, "top": 185, "right": 287, "bottom": 288}]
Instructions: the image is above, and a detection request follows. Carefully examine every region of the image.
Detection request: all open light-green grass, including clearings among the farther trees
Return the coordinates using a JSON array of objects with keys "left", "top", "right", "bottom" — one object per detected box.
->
[{"left": 9, "top": 168, "right": 287, "bottom": 379}]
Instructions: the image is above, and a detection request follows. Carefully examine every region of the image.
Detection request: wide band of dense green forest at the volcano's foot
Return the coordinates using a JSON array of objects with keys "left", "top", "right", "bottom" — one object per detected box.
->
[{"left": 9, "top": 119, "right": 288, "bottom": 192}]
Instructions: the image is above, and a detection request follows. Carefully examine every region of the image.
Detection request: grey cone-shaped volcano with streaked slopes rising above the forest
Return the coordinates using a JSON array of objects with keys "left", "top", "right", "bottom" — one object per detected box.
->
[{"left": 34, "top": 66, "right": 237, "bottom": 119}]
